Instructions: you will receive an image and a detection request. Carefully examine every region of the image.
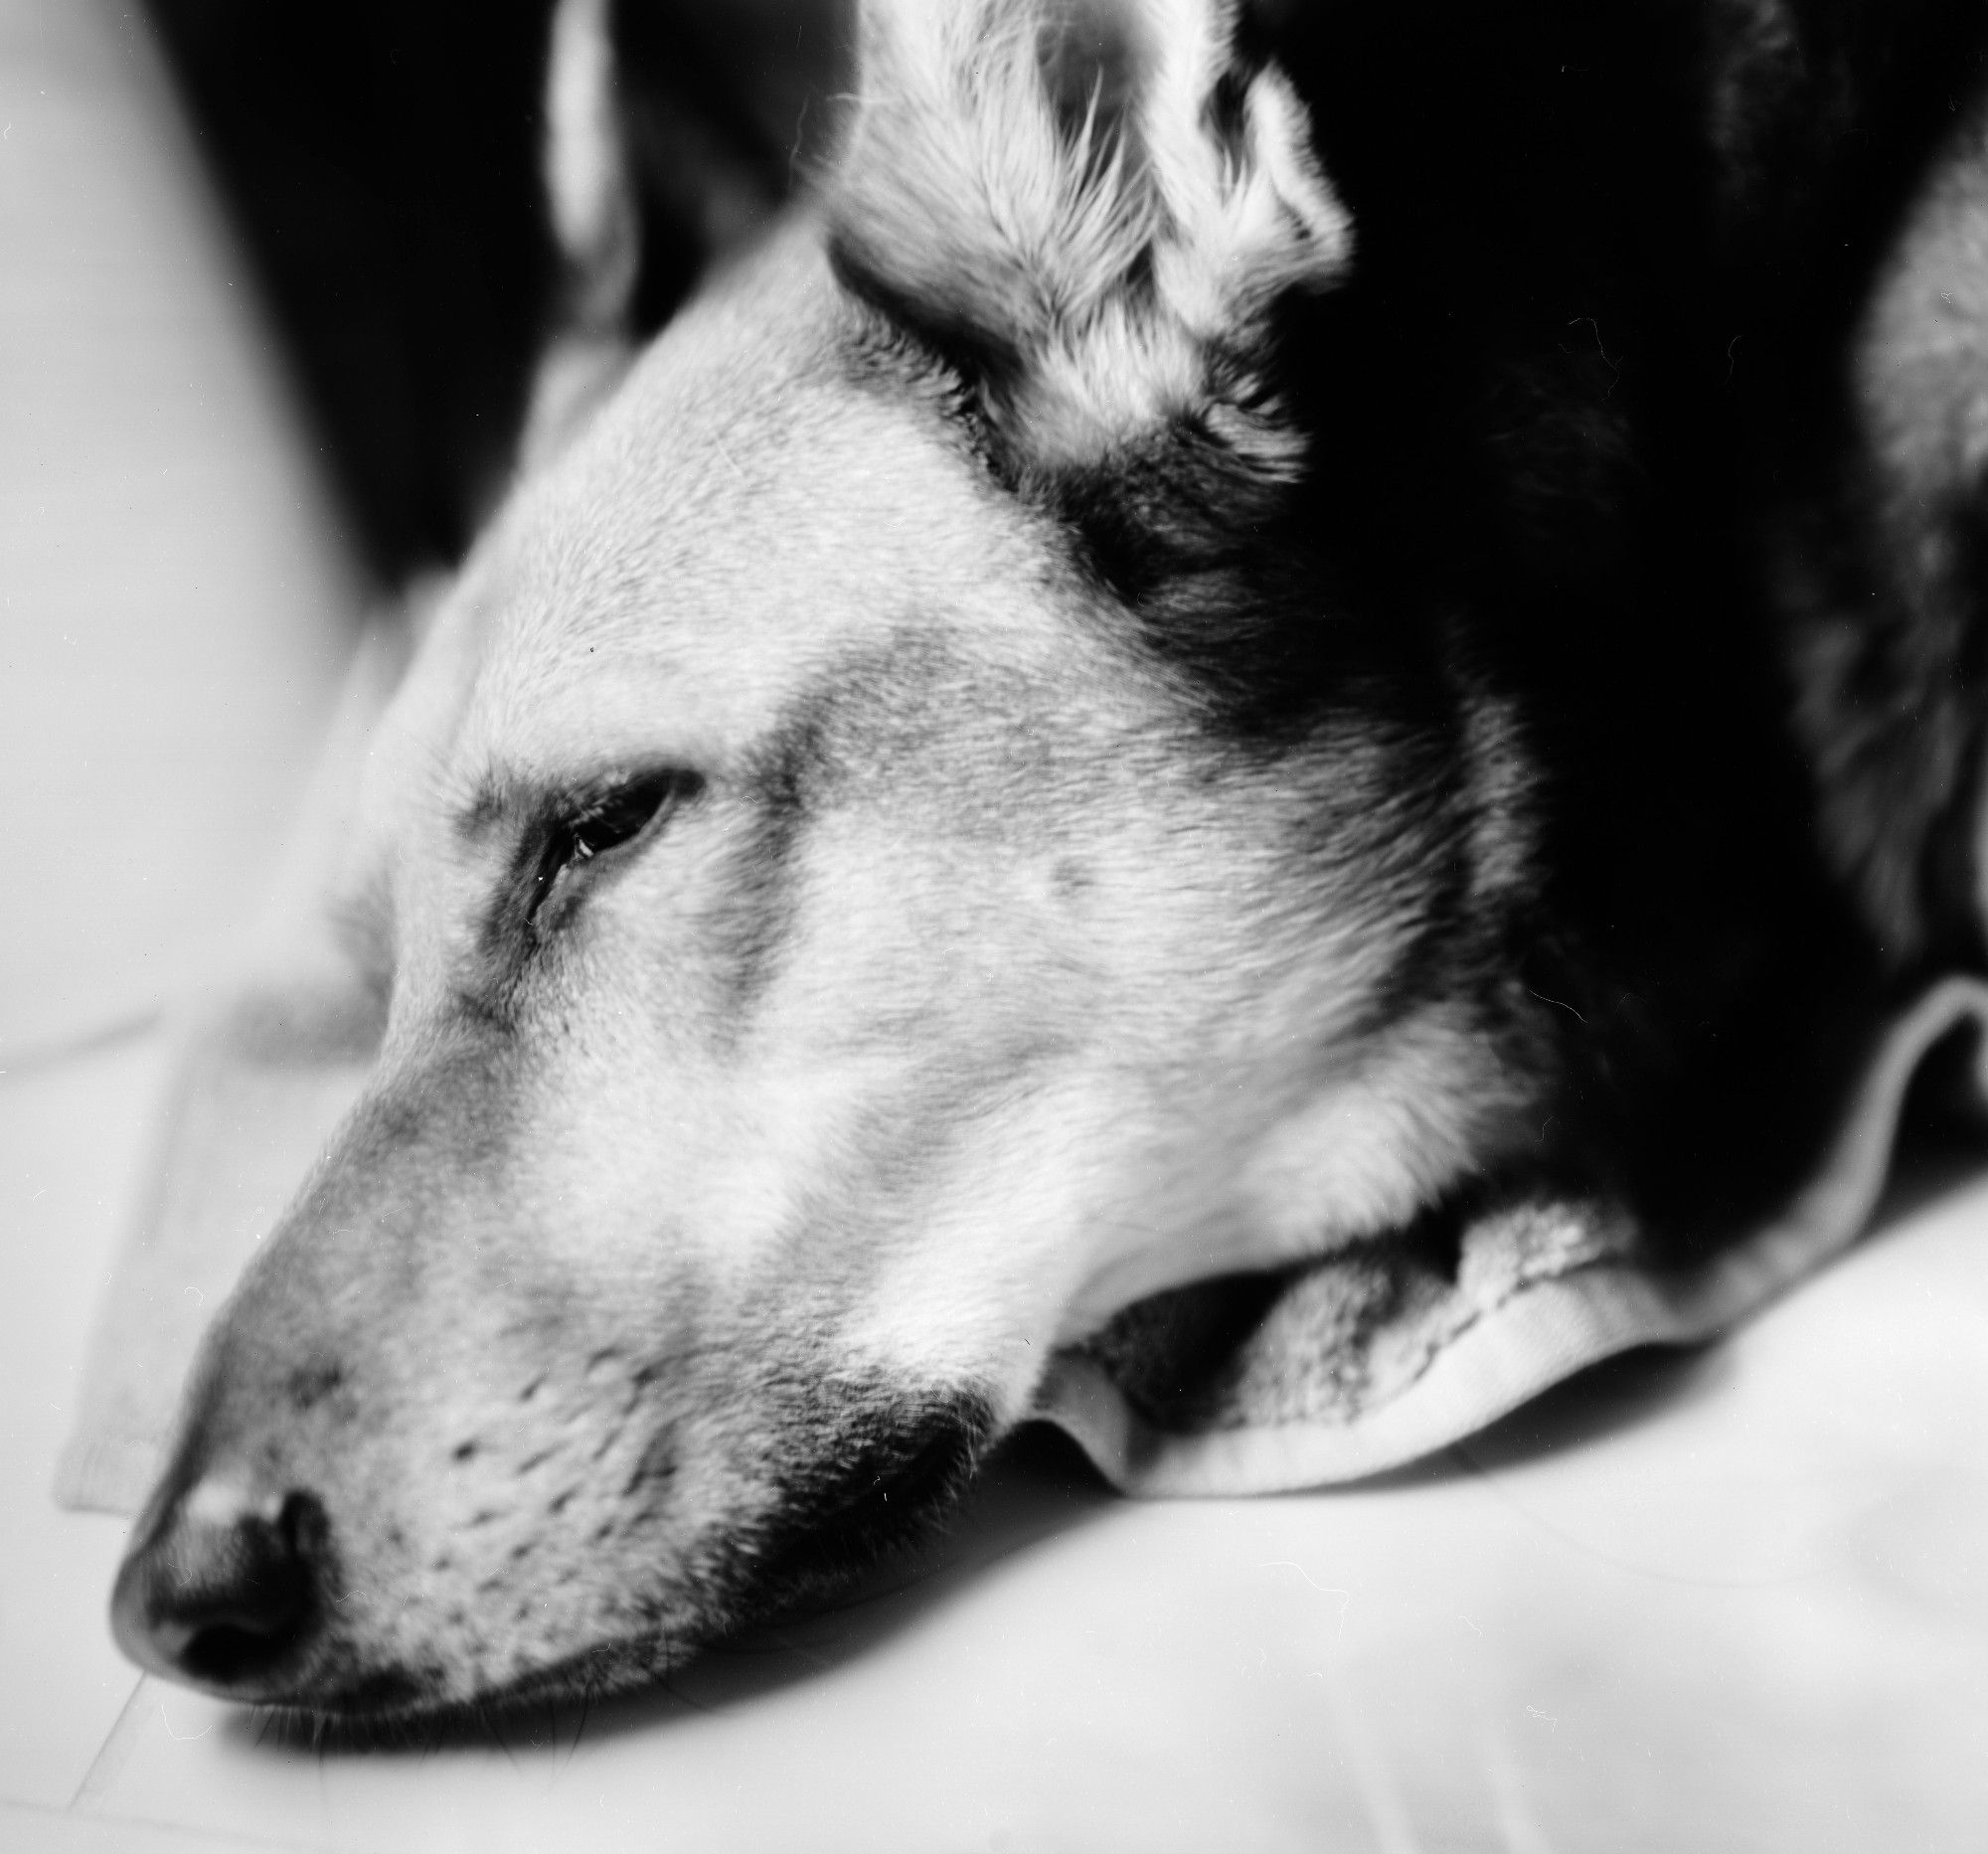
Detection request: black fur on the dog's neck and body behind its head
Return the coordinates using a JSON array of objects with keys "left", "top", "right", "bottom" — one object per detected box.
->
[{"left": 843, "top": 0, "right": 1980, "bottom": 1244}]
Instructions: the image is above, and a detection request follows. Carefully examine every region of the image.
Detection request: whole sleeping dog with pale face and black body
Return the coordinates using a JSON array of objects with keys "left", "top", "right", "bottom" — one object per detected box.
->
[{"left": 113, "top": 0, "right": 1988, "bottom": 1717}]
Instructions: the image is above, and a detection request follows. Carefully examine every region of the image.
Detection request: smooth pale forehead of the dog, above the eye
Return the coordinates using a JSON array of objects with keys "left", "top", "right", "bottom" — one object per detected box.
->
[{"left": 465, "top": 237, "right": 1083, "bottom": 769}]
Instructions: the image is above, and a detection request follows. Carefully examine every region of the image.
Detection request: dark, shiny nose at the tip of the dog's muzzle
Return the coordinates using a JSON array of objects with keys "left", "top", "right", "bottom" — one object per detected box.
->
[{"left": 111, "top": 1480, "right": 326, "bottom": 1699}]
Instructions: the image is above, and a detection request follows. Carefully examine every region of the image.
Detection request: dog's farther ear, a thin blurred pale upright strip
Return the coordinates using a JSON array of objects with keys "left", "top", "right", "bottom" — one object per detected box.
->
[{"left": 519, "top": 0, "right": 642, "bottom": 471}]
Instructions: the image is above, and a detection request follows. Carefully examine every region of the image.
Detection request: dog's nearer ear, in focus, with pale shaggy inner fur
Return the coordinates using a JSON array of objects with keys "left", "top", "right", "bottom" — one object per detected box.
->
[{"left": 831, "top": 0, "right": 1352, "bottom": 481}]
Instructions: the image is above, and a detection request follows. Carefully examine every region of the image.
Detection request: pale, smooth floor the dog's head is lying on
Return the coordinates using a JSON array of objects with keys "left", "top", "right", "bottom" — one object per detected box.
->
[{"left": 0, "top": 0, "right": 1988, "bottom": 1854}]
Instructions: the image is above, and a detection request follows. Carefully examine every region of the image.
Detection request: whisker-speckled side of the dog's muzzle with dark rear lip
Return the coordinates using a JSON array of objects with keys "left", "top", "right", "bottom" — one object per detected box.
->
[{"left": 320, "top": 1347, "right": 994, "bottom": 1705}]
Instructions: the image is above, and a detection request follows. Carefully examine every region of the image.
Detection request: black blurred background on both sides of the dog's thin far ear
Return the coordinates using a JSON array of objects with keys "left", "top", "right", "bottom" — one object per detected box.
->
[{"left": 145, "top": 0, "right": 847, "bottom": 583}]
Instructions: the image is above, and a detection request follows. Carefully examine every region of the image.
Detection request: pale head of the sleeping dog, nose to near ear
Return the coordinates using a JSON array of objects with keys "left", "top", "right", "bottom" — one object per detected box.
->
[{"left": 115, "top": 0, "right": 1525, "bottom": 1711}]
